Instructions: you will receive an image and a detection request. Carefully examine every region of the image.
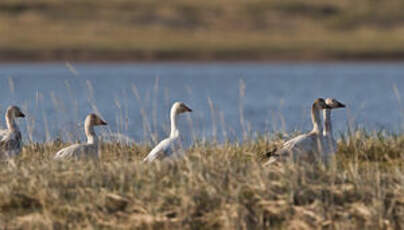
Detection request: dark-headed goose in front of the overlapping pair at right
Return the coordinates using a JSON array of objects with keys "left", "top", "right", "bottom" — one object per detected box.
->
[{"left": 264, "top": 98, "right": 331, "bottom": 166}]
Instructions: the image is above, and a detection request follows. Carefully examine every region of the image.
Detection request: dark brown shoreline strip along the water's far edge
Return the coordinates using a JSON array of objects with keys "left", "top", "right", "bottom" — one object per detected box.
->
[{"left": 0, "top": 50, "right": 404, "bottom": 63}]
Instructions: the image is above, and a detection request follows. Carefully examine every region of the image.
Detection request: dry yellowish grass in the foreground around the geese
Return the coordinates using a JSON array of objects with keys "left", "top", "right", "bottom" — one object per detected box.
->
[{"left": 0, "top": 131, "right": 404, "bottom": 229}]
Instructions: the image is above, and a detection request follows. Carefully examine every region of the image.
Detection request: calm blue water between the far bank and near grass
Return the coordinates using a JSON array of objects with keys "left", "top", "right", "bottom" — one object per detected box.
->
[{"left": 0, "top": 62, "right": 404, "bottom": 141}]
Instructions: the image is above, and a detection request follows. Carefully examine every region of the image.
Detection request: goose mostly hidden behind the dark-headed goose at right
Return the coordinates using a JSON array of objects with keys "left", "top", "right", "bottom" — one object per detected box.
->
[{"left": 323, "top": 98, "right": 345, "bottom": 162}]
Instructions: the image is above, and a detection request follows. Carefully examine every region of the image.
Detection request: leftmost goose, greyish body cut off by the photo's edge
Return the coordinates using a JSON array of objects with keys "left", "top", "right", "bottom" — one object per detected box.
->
[{"left": 0, "top": 106, "right": 25, "bottom": 158}]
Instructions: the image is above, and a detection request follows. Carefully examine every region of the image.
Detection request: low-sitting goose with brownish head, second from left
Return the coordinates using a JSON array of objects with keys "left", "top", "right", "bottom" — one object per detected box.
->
[{"left": 55, "top": 114, "right": 107, "bottom": 159}]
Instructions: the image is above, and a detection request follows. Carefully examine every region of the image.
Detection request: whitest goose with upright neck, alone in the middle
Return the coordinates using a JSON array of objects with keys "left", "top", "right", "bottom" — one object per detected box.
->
[{"left": 143, "top": 102, "right": 192, "bottom": 162}]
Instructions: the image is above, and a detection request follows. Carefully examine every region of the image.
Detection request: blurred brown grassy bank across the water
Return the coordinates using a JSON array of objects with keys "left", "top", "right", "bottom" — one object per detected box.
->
[{"left": 0, "top": 0, "right": 404, "bottom": 61}]
